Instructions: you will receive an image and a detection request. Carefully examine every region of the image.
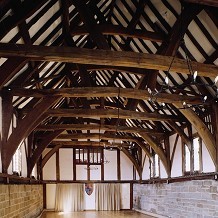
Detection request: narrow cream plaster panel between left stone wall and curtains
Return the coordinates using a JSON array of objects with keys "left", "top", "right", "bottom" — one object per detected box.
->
[{"left": 46, "top": 184, "right": 56, "bottom": 210}]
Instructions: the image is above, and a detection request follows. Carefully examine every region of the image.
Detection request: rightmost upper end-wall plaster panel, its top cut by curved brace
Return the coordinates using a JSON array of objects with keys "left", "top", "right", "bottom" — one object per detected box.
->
[{"left": 121, "top": 152, "right": 133, "bottom": 180}]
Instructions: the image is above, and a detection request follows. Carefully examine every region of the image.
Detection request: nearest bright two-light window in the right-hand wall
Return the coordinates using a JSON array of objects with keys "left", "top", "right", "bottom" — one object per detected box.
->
[{"left": 183, "top": 137, "right": 202, "bottom": 174}]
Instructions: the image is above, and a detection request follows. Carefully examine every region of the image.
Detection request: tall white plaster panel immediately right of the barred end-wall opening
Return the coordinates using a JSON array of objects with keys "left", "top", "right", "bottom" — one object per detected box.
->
[{"left": 104, "top": 150, "right": 117, "bottom": 180}]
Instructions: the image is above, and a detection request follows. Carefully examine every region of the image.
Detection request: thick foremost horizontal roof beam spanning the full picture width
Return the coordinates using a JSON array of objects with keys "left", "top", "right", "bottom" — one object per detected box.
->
[{"left": 0, "top": 43, "right": 218, "bottom": 77}]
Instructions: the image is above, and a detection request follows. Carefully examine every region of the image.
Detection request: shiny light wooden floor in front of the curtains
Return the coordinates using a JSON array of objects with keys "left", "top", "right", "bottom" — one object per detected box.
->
[{"left": 40, "top": 211, "right": 152, "bottom": 218}]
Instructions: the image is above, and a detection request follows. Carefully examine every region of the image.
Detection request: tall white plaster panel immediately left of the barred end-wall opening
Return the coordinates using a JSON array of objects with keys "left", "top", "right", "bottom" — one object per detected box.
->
[{"left": 59, "top": 148, "right": 73, "bottom": 180}]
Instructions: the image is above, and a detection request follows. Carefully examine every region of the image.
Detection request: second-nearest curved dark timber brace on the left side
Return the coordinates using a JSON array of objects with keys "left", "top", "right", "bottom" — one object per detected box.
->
[{"left": 27, "top": 129, "right": 64, "bottom": 176}]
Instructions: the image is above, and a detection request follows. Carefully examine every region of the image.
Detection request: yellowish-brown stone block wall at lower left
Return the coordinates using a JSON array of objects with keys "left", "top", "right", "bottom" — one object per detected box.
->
[{"left": 0, "top": 185, "right": 43, "bottom": 218}]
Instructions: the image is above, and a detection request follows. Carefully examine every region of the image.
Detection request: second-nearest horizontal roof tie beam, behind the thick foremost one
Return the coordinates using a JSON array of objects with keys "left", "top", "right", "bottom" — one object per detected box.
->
[{"left": 10, "top": 87, "right": 202, "bottom": 104}]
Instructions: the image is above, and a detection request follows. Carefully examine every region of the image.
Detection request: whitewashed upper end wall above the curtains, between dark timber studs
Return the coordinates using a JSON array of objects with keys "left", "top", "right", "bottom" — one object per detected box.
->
[{"left": 43, "top": 148, "right": 133, "bottom": 180}]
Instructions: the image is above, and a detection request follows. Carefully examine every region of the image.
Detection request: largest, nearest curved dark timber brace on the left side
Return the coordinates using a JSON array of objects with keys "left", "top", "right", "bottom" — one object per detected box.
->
[{"left": 1, "top": 97, "right": 59, "bottom": 172}]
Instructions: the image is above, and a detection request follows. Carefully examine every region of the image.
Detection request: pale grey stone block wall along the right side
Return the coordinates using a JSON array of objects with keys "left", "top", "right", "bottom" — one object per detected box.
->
[{"left": 133, "top": 180, "right": 218, "bottom": 218}]
